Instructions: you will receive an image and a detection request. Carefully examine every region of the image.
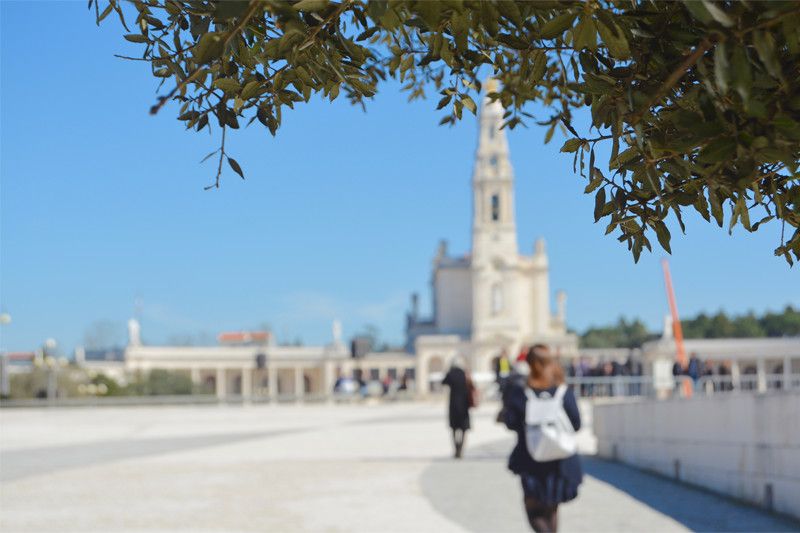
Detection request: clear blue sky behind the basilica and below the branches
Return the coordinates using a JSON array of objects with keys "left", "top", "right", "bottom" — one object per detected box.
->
[{"left": 0, "top": 1, "right": 800, "bottom": 353}]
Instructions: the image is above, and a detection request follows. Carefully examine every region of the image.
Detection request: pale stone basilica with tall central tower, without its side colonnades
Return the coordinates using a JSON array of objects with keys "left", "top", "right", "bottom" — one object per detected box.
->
[{"left": 406, "top": 80, "right": 577, "bottom": 387}]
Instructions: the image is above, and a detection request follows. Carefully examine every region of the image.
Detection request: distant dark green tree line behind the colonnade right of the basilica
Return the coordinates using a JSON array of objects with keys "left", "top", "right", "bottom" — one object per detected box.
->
[{"left": 580, "top": 305, "right": 800, "bottom": 348}]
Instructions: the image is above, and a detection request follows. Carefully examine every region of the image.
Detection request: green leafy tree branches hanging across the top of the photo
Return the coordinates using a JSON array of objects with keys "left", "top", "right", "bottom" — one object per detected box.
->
[{"left": 89, "top": 0, "right": 800, "bottom": 264}]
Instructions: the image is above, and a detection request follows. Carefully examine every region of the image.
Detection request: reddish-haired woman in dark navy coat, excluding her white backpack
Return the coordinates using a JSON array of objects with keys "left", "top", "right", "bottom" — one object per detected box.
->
[{"left": 503, "top": 344, "right": 583, "bottom": 532}]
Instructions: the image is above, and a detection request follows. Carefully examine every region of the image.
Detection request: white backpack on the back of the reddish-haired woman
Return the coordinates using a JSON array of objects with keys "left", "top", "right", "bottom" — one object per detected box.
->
[{"left": 525, "top": 384, "right": 578, "bottom": 463}]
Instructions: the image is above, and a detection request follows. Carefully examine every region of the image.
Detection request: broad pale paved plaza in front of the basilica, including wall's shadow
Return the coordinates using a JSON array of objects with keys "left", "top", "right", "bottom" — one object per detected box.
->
[{"left": 0, "top": 401, "right": 797, "bottom": 533}]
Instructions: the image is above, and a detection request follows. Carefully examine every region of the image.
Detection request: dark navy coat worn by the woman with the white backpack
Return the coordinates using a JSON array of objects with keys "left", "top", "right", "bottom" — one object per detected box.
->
[{"left": 503, "top": 381, "right": 583, "bottom": 504}]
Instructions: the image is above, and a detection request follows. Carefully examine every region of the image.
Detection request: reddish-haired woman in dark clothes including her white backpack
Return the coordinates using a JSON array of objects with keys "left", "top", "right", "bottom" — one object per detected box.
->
[{"left": 503, "top": 344, "right": 583, "bottom": 533}]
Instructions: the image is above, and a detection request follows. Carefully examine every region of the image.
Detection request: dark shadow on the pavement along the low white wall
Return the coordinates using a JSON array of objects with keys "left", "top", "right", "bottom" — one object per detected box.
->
[{"left": 582, "top": 456, "right": 800, "bottom": 531}]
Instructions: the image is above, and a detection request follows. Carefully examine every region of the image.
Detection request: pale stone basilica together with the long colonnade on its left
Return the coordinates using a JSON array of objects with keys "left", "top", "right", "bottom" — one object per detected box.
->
[{"left": 98, "top": 80, "right": 577, "bottom": 401}]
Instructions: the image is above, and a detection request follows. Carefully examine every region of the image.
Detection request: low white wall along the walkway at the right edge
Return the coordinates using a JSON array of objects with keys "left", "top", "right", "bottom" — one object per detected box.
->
[{"left": 594, "top": 391, "right": 800, "bottom": 518}]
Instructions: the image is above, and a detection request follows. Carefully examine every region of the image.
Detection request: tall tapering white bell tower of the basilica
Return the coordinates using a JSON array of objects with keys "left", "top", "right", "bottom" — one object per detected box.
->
[{"left": 472, "top": 78, "right": 524, "bottom": 339}]
